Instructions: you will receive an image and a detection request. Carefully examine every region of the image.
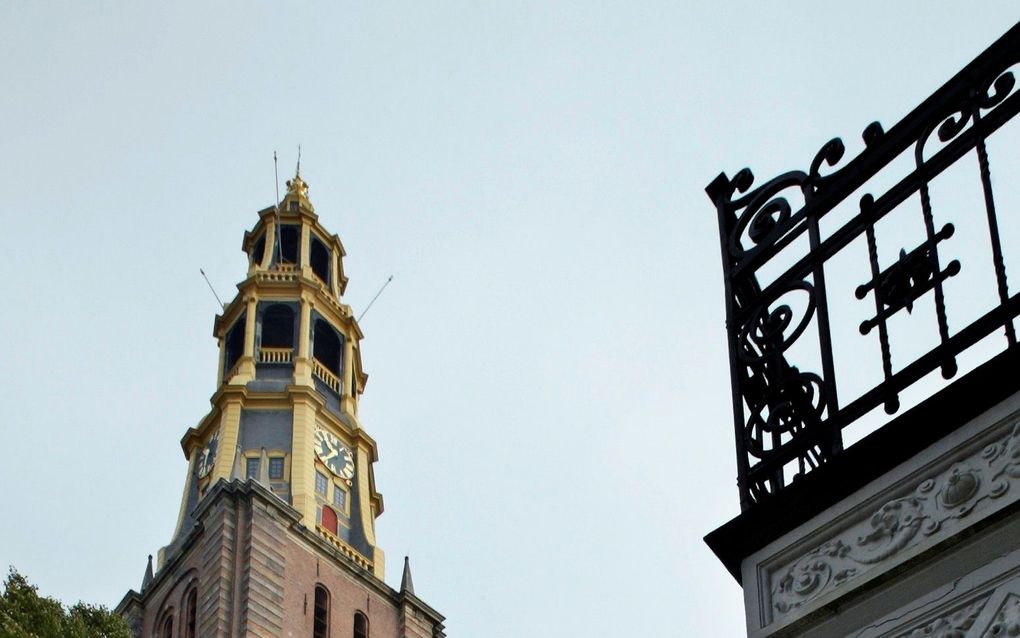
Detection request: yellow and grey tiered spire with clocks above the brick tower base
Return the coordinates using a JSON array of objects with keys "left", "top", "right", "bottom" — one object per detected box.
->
[{"left": 171, "top": 168, "right": 384, "bottom": 577}]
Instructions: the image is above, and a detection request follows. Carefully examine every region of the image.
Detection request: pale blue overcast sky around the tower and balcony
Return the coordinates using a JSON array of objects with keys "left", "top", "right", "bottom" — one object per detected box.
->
[{"left": 0, "top": 1, "right": 1020, "bottom": 638}]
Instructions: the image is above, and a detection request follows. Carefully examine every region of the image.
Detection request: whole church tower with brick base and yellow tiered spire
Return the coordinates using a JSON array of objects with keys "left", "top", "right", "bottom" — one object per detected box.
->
[{"left": 117, "top": 168, "right": 445, "bottom": 638}]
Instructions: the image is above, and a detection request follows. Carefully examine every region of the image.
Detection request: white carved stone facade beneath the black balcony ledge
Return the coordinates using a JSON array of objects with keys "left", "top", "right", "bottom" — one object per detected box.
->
[{"left": 742, "top": 393, "right": 1020, "bottom": 638}]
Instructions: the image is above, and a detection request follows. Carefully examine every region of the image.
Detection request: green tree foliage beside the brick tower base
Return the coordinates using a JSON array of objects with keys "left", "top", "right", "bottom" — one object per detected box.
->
[{"left": 0, "top": 568, "right": 131, "bottom": 638}]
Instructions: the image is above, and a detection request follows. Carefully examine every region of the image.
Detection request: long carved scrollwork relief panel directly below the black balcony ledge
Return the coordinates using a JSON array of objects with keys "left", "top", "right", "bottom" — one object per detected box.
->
[{"left": 771, "top": 423, "right": 1020, "bottom": 615}]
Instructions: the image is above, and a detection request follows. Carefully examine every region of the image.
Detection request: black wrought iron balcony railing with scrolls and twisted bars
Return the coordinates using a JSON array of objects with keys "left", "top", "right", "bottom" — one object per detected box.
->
[{"left": 706, "top": 24, "right": 1020, "bottom": 508}]
